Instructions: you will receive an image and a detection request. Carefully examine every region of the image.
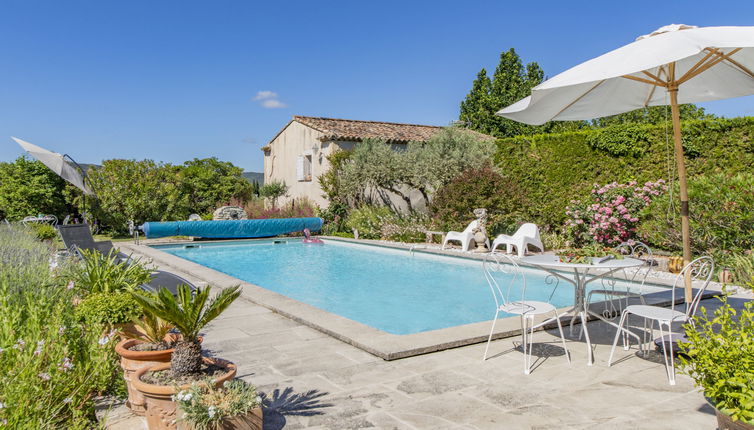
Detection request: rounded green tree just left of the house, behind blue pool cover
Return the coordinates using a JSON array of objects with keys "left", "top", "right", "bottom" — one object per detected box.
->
[{"left": 177, "top": 157, "right": 253, "bottom": 214}]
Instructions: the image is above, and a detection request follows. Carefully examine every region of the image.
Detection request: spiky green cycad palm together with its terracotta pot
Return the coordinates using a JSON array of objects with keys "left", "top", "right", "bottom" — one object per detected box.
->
[{"left": 131, "top": 285, "right": 241, "bottom": 430}]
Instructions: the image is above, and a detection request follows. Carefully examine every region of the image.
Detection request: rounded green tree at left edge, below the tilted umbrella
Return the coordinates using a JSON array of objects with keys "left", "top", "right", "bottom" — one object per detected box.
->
[{"left": 0, "top": 156, "right": 68, "bottom": 220}]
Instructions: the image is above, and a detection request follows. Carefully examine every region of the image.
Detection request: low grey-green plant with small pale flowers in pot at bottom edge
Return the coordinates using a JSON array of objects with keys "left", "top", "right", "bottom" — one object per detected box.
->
[{"left": 175, "top": 379, "right": 263, "bottom": 430}]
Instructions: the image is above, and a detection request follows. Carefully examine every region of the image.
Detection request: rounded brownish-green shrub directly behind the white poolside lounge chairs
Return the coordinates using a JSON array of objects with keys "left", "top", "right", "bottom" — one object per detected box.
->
[{"left": 429, "top": 165, "right": 529, "bottom": 235}]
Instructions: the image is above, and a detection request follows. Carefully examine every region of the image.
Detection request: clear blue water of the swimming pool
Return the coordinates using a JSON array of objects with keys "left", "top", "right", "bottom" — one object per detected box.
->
[{"left": 156, "top": 239, "right": 648, "bottom": 334}]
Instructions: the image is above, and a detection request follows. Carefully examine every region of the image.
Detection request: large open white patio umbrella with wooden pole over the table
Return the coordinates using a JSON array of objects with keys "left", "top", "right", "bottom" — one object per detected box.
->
[{"left": 497, "top": 24, "right": 754, "bottom": 301}]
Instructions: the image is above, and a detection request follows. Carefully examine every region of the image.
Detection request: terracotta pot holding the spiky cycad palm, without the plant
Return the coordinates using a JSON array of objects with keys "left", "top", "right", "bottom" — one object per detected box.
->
[{"left": 131, "top": 357, "right": 236, "bottom": 430}]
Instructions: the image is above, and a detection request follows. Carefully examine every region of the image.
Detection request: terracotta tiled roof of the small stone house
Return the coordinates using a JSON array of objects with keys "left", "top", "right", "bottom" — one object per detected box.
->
[{"left": 293, "top": 116, "right": 492, "bottom": 143}]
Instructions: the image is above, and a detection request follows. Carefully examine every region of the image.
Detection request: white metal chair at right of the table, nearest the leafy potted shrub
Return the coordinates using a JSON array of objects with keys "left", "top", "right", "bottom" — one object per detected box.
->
[{"left": 607, "top": 257, "right": 715, "bottom": 385}]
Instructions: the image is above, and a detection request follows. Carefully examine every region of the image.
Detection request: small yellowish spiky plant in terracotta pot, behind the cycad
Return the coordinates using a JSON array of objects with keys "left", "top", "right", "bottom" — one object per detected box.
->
[{"left": 115, "top": 313, "right": 178, "bottom": 415}]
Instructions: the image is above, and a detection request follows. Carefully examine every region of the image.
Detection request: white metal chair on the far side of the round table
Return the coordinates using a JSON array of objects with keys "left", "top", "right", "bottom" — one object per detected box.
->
[{"left": 586, "top": 242, "right": 655, "bottom": 318}]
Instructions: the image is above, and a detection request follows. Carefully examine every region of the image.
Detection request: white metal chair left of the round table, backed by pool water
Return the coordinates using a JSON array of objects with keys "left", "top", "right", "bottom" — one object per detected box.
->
[{"left": 482, "top": 254, "right": 571, "bottom": 375}]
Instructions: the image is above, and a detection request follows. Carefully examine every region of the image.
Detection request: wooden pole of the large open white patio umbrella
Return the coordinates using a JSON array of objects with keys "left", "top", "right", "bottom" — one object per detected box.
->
[{"left": 668, "top": 85, "right": 693, "bottom": 303}]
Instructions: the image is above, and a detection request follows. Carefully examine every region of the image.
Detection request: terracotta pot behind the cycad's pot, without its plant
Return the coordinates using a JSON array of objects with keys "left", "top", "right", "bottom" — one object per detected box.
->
[{"left": 115, "top": 334, "right": 202, "bottom": 415}]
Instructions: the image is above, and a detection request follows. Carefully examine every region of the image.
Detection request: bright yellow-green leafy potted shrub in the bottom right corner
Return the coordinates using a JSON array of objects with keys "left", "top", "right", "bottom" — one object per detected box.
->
[{"left": 679, "top": 297, "right": 754, "bottom": 430}]
